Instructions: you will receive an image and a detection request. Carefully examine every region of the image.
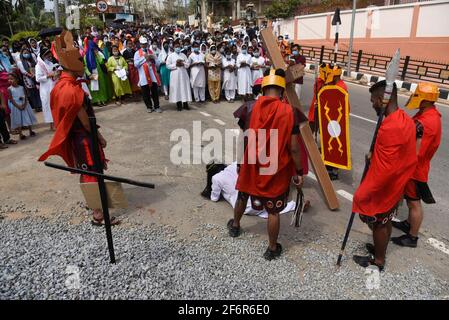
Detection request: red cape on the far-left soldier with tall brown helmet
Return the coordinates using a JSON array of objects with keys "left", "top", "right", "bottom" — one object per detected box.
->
[{"left": 39, "top": 72, "right": 84, "bottom": 167}]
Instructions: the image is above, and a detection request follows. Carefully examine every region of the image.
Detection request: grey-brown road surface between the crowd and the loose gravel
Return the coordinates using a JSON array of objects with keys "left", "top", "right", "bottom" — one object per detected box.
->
[{"left": 0, "top": 77, "right": 449, "bottom": 297}]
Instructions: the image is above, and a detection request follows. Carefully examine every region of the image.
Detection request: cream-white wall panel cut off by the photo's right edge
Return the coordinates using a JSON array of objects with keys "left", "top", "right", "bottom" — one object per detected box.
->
[{"left": 416, "top": 3, "right": 449, "bottom": 37}]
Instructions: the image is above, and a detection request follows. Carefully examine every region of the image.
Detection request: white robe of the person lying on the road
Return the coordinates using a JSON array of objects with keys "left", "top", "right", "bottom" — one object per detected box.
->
[{"left": 210, "top": 162, "right": 296, "bottom": 219}]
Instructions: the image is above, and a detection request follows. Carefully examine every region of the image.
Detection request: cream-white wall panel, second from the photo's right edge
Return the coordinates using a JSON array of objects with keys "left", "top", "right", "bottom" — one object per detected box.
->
[{"left": 371, "top": 6, "right": 413, "bottom": 38}]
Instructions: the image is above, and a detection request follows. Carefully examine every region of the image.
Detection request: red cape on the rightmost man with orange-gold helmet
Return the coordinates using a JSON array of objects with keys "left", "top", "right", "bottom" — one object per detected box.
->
[{"left": 413, "top": 106, "right": 441, "bottom": 182}]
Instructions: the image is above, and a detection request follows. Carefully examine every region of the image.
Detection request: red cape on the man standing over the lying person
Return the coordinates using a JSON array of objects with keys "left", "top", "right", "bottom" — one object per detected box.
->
[{"left": 236, "top": 97, "right": 295, "bottom": 198}]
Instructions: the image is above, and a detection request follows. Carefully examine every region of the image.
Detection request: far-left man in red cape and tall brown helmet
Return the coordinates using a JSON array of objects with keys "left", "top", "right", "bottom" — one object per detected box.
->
[{"left": 39, "top": 32, "right": 118, "bottom": 225}]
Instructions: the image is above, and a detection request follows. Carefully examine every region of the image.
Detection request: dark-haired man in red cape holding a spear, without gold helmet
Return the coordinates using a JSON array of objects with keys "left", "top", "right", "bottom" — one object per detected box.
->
[{"left": 352, "top": 80, "right": 417, "bottom": 271}]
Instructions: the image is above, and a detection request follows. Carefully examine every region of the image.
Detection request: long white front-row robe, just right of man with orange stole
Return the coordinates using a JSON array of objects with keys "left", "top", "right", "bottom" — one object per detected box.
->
[{"left": 167, "top": 52, "right": 192, "bottom": 103}]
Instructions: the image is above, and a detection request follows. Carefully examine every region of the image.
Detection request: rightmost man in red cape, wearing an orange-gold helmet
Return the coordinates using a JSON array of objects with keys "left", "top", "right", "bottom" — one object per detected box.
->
[{"left": 391, "top": 82, "right": 442, "bottom": 248}]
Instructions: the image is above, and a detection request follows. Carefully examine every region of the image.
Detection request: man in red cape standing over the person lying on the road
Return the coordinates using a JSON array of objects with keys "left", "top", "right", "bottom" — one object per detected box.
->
[{"left": 227, "top": 69, "right": 303, "bottom": 260}]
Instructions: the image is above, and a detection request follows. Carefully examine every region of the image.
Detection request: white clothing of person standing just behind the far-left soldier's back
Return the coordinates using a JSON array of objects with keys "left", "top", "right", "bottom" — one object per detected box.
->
[{"left": 36, "top": 57, "right": 58, "bottom": 123}]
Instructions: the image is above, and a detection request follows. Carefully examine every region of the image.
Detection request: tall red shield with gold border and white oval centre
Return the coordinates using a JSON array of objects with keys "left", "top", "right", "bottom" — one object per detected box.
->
[{"left": 318, "top": 85, "right": 351, "bottom": 170}]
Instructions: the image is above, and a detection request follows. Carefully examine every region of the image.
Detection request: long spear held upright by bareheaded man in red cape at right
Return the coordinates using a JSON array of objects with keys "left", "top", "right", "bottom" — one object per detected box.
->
[{"left": 337, "top": 49, "right": 401, "bottom": 266}]
